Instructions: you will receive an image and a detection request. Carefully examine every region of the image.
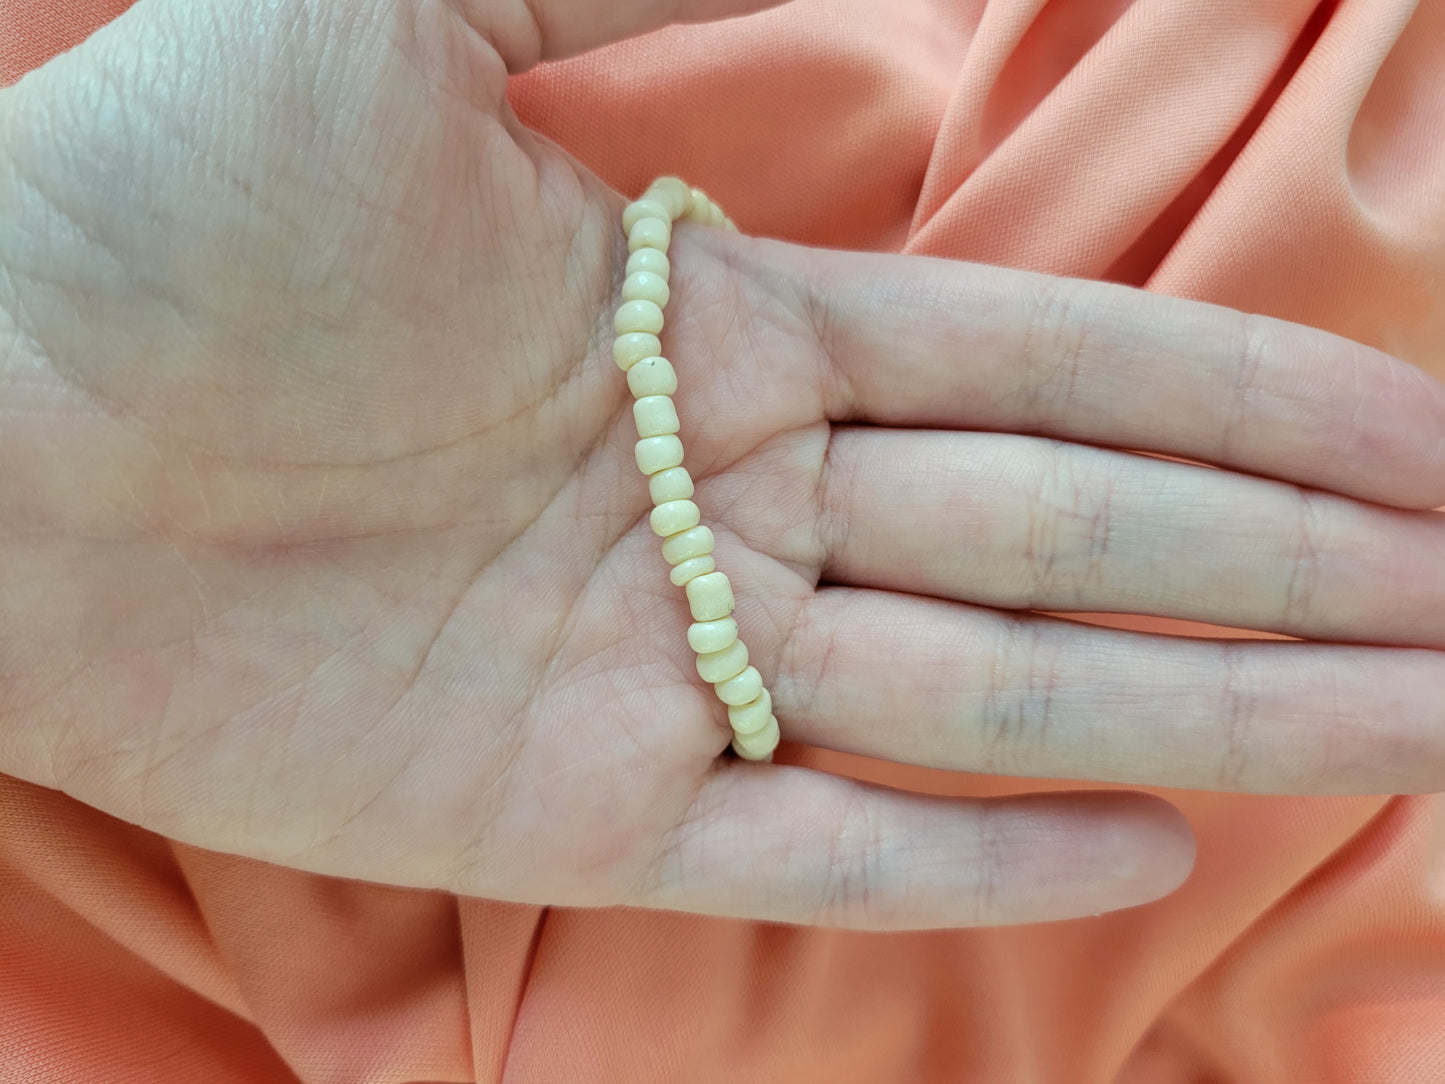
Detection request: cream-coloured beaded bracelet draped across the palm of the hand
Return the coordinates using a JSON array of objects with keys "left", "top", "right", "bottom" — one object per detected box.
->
[{"left": 613, "top": 176, "right": 777, "bottom": 760}]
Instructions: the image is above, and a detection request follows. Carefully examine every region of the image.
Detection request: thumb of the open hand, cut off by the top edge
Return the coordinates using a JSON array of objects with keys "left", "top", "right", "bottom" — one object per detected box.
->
[{"left": 454, "top": 0, "right": 782, "bottom": 75}]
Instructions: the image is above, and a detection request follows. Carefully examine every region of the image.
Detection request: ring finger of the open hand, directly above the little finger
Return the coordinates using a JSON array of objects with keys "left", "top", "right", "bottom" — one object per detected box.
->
[{"left": 772, "top": 588, "right": 1445, "bottom": 793}]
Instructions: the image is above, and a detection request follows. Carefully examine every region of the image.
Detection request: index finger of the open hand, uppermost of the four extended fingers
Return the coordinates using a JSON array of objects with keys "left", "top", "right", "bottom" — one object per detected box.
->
[{"left": 770, "top": 246, "right": 1445, "bottom": 507}]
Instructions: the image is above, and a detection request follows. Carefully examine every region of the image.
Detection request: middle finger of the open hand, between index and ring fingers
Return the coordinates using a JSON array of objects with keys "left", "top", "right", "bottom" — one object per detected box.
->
[{"left": 819, "top": 428, "right": 1445, "bottom": 646}]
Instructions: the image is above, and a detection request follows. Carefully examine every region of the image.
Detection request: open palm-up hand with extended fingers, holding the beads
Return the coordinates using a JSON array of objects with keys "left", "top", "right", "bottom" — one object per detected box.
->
[{"left": 0, "top": 0, "right": 1445, "bottom": 928}]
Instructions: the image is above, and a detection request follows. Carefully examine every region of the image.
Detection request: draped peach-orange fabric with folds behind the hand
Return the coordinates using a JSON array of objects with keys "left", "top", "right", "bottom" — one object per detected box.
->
[{"left": 0, "top": 0, "right": 1445, "bottom": 1084}]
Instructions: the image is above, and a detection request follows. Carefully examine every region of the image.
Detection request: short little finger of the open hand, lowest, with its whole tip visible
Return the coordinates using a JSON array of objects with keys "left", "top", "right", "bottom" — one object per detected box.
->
[{"left": 643, "top": 762, "right": 1194, "bottom": 929}]
